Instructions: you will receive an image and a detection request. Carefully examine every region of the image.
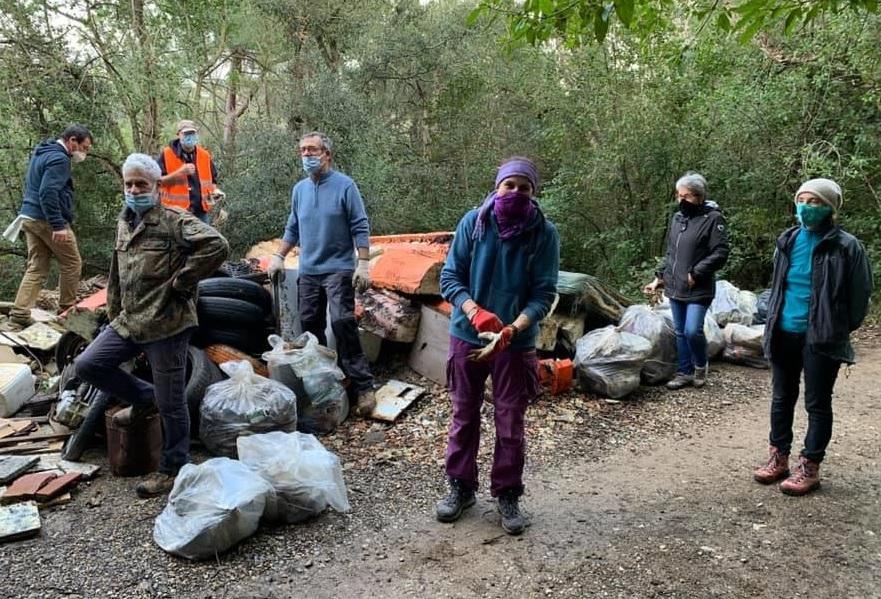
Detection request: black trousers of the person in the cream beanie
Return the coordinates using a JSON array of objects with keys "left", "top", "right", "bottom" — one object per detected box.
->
[{"left": 769, "top": 330, "right": 841, "bottom": 463}]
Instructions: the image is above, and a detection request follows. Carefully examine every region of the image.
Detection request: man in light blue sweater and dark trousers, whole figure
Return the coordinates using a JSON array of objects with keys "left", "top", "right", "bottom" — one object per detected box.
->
[{"left": 268, "top": 131, "right": 376, "bottom": 417}]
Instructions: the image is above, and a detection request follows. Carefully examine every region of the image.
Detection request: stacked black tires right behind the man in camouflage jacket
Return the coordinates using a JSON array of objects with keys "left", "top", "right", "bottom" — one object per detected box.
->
[{"left": 194, "top": 277, "right": 272, "bottom": 355}]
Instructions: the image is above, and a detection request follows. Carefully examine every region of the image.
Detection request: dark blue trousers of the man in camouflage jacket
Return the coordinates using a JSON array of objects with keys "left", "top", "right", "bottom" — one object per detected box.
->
[{"left": 76, "top": 327, "right": 191, "bottom": 476}]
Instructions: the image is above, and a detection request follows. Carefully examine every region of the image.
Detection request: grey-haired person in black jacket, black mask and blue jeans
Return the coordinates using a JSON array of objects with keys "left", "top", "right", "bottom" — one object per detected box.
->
[{"left": 643, "top": 173, "right": 729, "bottom": 389}]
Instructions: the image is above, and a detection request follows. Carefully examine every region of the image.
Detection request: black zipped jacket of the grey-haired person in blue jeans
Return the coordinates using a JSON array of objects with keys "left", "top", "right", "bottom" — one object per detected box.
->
[{"left": 655, "top": 201, "right": 729, "bottom": 302}]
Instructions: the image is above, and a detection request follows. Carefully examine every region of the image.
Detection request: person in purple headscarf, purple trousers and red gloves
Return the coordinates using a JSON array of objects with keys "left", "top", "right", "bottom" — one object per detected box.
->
[{"left": 437, "top": 157, "right": 560, "bottom": 535}]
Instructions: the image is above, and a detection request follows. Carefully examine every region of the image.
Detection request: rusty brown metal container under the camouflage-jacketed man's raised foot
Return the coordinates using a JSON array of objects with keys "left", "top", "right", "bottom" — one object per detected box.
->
[{"left": 104, "top": 406, "right": 162, "bottom": 476}]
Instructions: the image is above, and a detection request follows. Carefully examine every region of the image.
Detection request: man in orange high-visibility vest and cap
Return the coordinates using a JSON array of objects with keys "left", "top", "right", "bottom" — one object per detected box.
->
[{"left": 156, "top": 119, "right": 217, "bottom": 223}]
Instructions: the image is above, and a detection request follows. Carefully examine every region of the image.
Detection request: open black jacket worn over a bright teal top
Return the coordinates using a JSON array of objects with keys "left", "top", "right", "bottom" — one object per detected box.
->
[{"left": 764, "top": 225, "right": 874, "bottom": 364}]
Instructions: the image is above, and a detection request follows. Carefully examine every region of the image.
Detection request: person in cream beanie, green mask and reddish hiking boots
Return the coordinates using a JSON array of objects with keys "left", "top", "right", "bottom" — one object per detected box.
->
[{"left": 753, "top": 179, "right": 873, "bottom": 495}]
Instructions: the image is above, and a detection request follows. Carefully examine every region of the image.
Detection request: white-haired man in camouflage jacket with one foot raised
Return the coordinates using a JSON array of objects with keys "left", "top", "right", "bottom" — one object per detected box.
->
[{"left": 75, "top": 154, "right": 229, "bottom": 497}]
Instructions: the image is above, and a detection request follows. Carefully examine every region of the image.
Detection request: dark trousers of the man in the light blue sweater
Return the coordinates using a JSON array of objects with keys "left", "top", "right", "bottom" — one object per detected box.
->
[{"left": 297, "top": 270, "right": 373, "bottom": 393}]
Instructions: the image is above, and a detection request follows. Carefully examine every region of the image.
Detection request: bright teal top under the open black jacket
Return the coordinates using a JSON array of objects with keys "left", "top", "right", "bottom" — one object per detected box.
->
[{"left": 780, "top": 227, "right": 823, "bottom": 333}]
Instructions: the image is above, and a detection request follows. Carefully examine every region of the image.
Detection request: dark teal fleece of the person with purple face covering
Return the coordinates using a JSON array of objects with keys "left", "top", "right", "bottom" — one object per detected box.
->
[{"left": 440, "top": 204, "right": 560, "bottom": 351}]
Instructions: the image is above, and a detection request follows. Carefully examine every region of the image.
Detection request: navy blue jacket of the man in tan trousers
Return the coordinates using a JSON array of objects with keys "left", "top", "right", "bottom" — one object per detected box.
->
[{"left": 21, "top": 139, "right": 74, "bottom": 231}]
